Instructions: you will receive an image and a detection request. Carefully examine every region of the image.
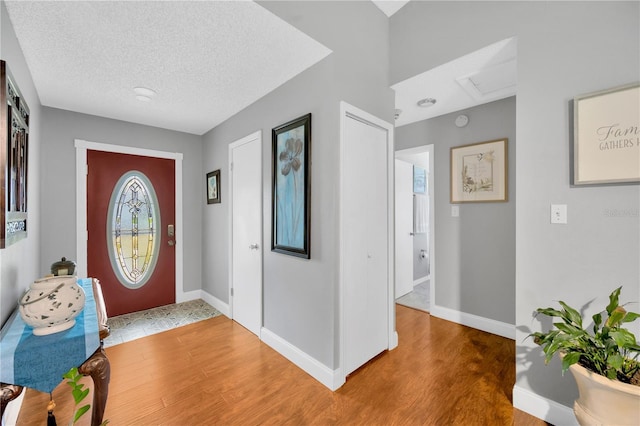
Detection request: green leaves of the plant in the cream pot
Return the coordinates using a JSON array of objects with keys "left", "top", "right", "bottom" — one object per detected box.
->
[{"left": 529, "top": 287, "right": 640, "bottom": 384}]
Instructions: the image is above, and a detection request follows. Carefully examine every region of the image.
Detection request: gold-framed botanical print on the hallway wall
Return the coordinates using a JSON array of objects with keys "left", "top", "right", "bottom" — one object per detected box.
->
[{"left": 451, "top": 138, "right": 508, "bottom": 204}]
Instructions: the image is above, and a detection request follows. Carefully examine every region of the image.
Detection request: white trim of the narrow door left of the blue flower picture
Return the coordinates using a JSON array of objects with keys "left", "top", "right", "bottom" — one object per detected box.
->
[{"left": 227, "top": 130, "right": 264, "bottom": 332}]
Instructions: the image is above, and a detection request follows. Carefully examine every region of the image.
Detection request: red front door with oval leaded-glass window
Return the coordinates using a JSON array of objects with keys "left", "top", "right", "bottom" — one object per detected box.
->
[{"left": 87, "top": 150, "right": 175, "bottom": 316}]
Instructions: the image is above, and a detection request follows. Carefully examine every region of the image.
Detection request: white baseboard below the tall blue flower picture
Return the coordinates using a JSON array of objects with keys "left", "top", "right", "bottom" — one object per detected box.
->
[{"left": 260, "top": 327, "right": 345, "bottom": 391}]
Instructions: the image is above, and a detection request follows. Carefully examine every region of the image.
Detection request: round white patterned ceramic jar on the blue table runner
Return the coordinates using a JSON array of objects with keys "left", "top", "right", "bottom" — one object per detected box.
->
[{"left": 19, "top": 275, "right": 85, "bottom": 336}]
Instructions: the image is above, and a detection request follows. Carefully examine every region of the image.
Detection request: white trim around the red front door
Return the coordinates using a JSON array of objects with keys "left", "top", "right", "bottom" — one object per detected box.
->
[{"left": 75, "top": 139, "right": 188, "bottom": 303}]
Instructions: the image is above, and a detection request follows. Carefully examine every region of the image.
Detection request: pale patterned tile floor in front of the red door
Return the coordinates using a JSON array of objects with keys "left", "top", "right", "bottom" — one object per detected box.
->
[{"left": 104, "top": 299, "right": 222, "bottom": 348}]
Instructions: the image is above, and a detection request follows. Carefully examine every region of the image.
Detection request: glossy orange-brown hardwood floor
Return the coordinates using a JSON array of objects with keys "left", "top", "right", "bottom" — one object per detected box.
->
[{"left": 18, "top": 306, "right": 546, "bottom": 426}]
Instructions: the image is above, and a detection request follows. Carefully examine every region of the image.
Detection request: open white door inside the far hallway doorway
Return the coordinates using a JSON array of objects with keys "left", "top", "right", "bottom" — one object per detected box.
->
[{"left": 395, "top": 159, "right": 413, "bottom": 299}]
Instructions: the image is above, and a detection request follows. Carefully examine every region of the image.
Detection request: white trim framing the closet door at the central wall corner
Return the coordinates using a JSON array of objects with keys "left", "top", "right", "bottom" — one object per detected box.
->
[{"left": 337, "top": 101, "right": 398, "bottom": 387}]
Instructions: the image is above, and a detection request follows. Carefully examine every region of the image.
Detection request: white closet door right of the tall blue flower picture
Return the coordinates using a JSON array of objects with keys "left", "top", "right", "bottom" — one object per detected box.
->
[{"left": 341, "top": 110, "right": 392, "bottom": 375}]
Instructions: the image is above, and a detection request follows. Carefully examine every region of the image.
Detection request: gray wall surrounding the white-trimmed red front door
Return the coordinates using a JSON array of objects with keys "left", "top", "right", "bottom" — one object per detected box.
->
[{"left": 40, "top": 107, "right": 204, "bottom": 291}]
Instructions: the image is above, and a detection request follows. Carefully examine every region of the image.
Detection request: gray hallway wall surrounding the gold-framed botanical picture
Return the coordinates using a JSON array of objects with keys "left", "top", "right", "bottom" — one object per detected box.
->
[{"left": 396, "top": 97, "right": 517, "bottom": 324}]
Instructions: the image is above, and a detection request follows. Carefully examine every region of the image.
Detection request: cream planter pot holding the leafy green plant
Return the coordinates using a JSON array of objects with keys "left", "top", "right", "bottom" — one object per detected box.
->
[{"left": 569, "top": 364, "right": 640, "bottom": 426}]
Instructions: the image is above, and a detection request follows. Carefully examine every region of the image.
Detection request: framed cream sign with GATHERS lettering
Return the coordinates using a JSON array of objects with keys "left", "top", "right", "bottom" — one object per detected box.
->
[{"left": 571, "top": 83, "right": 640, "bottom": 186}]
